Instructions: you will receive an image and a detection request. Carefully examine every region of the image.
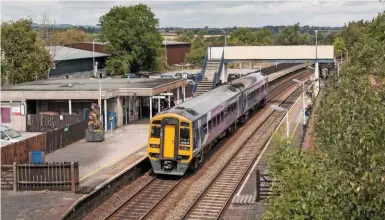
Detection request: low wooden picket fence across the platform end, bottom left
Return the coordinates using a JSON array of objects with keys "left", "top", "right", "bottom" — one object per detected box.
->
[{"left": 1, "top": 162, "right": 79, "bottom": 192}]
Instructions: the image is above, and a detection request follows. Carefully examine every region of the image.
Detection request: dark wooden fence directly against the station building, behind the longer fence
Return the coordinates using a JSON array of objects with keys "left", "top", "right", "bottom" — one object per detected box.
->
[{"left": 26, "top": 114, "right": 83, "bottom": 132}]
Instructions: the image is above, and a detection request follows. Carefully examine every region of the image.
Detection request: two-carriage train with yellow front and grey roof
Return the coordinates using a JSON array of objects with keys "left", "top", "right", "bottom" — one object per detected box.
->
[{"left": 147, "top": 72, "right": 268, "bottom": 176}]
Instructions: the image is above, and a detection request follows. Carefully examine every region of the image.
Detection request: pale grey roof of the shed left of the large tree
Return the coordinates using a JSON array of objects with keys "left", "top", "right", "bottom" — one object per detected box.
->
[{"left": 48, "top": 46, "right": 109, "bottom": 61}]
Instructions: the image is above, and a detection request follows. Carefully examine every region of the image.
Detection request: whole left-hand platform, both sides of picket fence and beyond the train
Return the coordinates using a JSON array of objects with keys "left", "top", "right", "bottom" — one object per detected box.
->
[{"left": 1, "top": 67, "right": 303, "bottom": 220}]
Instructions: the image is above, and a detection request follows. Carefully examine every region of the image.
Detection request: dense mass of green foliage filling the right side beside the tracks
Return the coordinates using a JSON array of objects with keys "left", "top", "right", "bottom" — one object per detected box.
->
[{"left": 264, "top": 12, "right": 385, "bottom": 220}]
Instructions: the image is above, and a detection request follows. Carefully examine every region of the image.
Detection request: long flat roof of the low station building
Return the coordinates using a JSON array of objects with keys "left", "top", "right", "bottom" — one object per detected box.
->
[{"left": 1, "top": 78, "right": 186, "bottom": 101}]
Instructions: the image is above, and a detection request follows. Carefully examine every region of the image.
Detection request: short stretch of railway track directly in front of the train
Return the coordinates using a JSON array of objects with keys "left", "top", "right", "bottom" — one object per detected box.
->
[{"left": 105, "top": 177, "right": 182, "bottom": 220}]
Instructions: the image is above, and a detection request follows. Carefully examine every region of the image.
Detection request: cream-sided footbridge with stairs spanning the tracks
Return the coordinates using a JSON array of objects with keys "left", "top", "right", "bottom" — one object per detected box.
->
[{"left": 194, "top": 45, "right": 335, "bottom": 93}]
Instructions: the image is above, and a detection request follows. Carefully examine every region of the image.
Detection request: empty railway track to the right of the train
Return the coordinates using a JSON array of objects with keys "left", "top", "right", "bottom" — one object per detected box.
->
[{"left": 182, "top": 74, "right": 304, "bottom": 219}]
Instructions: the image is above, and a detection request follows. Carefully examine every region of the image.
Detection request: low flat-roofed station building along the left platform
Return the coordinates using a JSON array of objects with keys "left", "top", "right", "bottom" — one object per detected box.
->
[{"left": 1, "top": 78, "right": 192, "bottom": 131}]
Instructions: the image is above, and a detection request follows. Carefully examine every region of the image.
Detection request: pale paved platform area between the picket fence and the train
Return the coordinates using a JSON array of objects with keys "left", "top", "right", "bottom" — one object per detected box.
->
[{"left": 46, "top": 119, "right": 149, "bottom": 184}]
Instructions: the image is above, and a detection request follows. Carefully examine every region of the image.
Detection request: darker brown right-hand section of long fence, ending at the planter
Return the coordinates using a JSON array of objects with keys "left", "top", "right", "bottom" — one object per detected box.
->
[{"left": 45, "top": 120, "right": 88, "bottom": 154}]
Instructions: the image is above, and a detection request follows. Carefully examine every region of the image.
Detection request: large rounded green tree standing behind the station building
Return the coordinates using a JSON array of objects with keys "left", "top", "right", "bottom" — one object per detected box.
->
[{"left": 99, "top": 4, "right": 162, "bottom": 74}]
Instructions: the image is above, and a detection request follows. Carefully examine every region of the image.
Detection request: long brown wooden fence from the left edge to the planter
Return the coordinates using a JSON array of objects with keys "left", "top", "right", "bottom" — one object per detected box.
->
[{"left": 1, "top": 120, "right": 88, "bottom": 164}]
